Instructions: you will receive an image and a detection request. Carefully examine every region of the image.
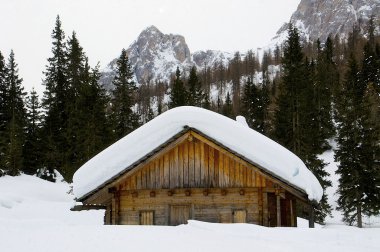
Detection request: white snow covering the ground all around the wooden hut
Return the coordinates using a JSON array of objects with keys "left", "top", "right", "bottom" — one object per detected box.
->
[{"left": 0, "top": 152, "right": 380, "bottom": 252}]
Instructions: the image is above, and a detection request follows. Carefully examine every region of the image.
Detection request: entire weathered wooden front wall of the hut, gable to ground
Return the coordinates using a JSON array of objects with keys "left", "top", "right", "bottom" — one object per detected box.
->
[{"left": 101, "top": 134, "right": 296, "bottom": 226}]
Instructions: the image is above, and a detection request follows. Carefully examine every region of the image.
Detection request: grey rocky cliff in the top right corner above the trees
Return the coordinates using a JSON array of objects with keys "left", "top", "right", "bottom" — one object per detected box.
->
[{"left": 274, "top": 0, "right": 380, "bottom": 42}]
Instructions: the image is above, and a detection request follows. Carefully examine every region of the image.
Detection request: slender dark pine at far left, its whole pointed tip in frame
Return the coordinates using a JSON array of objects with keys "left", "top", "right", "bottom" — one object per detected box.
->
[{"left": 4, "top": 51, "right": 26, "bottom": 176}]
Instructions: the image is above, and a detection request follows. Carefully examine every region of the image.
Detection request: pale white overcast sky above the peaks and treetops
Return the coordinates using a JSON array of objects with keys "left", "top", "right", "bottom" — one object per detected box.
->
[{"left": 0, "top": 0, "right": 300, "bottom": 93}]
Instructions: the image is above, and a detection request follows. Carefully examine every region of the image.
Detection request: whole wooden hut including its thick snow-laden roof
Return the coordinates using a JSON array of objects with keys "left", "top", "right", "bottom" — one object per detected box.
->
[{"left": 74, "top": 107, "right": 321, "bottom": 227}]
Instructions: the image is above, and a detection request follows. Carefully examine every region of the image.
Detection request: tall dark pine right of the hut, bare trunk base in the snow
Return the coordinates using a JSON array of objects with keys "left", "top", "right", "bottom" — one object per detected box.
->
[{"left": 335, "top": 55, "right": 365, "bottom": 227}]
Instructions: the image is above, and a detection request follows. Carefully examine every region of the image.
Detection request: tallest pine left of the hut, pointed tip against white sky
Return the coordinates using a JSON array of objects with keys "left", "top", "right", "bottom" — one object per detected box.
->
[{"left": 39, "top": 16, "right": 69, "bottom": 180}]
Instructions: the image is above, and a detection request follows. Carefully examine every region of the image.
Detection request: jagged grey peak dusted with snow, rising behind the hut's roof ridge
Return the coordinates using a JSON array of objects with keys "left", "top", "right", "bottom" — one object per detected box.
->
[{"left": 101, "top": 26, "right": 232, "bottom": 89}]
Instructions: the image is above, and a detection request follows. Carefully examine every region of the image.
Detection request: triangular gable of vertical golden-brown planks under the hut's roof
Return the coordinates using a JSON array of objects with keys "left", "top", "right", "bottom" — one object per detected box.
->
[{"left": 119, "top": 138, "right": 266, "bottom": 190}]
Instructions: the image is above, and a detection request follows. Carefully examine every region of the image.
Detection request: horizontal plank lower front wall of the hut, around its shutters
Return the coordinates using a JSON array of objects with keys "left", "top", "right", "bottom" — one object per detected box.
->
[{"left": 115, "top": 188, "right": 262, "bottom": 225}]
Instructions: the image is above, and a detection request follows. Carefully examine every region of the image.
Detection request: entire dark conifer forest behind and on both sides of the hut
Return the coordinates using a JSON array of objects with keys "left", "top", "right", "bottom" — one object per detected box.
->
[{"left": 0, "top": 16, "right": 380, "bottom": 227}]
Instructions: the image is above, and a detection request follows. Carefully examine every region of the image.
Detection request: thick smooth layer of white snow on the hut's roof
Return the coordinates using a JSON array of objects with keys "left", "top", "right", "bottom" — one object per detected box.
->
[{"left": 73, "top": 107, "right": 323, "bottom": 201}]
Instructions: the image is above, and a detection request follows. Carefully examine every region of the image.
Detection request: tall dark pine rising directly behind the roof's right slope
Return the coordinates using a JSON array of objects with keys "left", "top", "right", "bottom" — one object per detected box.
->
[{"left": 274, "top": 25, "right": 331, "bottom": 222}]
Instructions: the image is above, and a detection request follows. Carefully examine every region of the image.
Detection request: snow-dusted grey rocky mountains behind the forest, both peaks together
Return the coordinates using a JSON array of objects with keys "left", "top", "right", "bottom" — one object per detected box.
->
[{"left": 101, "top": 0, "right": 380, "bottom": 89}]
